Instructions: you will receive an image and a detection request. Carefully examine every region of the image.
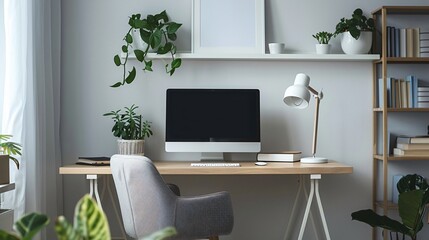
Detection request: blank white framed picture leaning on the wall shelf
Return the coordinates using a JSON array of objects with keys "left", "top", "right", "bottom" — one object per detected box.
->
[{"left": 192, "top": 0, "right": 265, "bottom": 54}]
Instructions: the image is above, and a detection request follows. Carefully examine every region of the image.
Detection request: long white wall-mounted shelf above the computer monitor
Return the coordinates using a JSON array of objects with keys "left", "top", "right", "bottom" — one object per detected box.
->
[{"left": 122, "top": 53, "right": 380, "bottom": 62}]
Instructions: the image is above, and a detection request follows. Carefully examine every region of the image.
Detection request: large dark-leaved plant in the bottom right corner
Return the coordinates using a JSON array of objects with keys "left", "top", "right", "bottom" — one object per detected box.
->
[{"left": 352, "top": 174, "right": 429, "bottom": 240}]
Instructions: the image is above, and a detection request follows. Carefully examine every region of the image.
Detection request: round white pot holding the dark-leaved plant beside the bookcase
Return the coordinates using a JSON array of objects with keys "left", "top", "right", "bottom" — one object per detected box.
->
[{"left": 341, "top": 32, "right": 372, "bottom": 54}]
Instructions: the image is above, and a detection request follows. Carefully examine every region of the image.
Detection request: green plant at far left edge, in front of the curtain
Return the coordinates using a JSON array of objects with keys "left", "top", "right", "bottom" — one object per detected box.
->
[{"left": 0, "top": 134, "right": 21, "bottom": 184}]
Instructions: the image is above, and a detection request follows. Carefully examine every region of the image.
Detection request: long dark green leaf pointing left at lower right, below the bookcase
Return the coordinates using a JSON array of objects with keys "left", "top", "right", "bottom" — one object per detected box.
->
[{"left": 352, "top": 209, "right": 409, "bottom": 235}]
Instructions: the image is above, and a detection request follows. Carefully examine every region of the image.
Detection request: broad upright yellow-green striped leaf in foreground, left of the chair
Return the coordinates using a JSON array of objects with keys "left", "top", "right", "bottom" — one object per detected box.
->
[{"left": 74, "top": 194, "right": 110, "bottom": 240}]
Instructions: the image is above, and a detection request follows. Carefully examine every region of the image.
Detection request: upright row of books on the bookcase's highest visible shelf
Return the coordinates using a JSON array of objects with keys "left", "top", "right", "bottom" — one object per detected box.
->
[{"left": 386, "top": 26, "right": 429, "bottom": 57}]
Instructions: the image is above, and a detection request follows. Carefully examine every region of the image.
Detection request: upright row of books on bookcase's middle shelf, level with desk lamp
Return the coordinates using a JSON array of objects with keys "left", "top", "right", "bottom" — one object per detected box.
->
[{"left": 377, "top": 75, "right": 429, "bottom": 108}]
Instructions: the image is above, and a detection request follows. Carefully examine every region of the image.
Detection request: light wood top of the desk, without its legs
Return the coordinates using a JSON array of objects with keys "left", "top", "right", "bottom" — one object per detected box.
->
[{"left": 59, "top": 161, "right": 353, "bottom": 175}]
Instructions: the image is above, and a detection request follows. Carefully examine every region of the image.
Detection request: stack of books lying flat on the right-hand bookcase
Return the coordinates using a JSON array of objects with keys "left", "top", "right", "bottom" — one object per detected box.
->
[{"left": 393, "top": 135, "right": 429, "bottom": 157}]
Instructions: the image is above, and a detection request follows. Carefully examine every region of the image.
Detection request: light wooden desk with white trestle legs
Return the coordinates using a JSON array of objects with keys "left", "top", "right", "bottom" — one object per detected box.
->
[{"left": 59, "top": 161, "right": 353, "bottom": 240}]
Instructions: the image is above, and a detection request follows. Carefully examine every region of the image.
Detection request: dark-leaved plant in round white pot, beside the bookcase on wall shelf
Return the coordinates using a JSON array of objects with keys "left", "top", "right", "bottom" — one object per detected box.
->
[{"left": 334, "top": 8, "right": 375, "bottom": 54}]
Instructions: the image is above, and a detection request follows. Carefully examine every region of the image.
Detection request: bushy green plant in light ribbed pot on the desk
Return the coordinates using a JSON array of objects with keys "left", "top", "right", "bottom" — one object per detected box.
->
[{"left": 103, "top": 104, "right": 153, "bottom": 155}]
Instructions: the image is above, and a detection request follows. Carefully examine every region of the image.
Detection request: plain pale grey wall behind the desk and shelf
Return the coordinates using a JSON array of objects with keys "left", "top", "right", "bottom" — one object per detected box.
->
[{"left": 61, "top": 0, "right": 427, "bottom": 240}]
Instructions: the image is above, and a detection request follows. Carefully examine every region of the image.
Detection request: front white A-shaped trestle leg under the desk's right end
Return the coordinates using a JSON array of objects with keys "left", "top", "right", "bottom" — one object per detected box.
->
[{"left": 298, "top": 174, "right": 331, "bottom": 240}]
